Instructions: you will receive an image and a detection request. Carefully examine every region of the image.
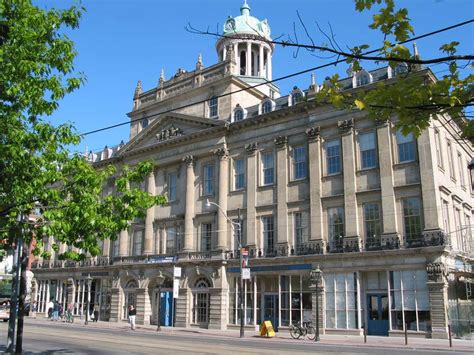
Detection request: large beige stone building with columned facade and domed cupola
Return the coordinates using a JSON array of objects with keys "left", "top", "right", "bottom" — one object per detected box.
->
[{"left": 33, "top": 3, "right": 474, "bottom": 337}]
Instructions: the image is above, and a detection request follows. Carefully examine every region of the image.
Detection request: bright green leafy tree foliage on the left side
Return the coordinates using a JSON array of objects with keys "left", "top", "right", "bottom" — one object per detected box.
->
[{"left": 0, "top": 0, "right": 165, "bottom": 260}]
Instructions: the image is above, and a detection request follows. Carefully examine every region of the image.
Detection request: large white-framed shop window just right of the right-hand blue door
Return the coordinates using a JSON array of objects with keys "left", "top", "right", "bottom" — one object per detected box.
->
[{"left": 389, "top": 270, "right": 431, "bottom": 331}]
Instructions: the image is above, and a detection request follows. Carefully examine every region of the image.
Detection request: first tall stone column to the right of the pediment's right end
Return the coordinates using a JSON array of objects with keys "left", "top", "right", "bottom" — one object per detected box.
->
[{"left": 245, "top": 143, "right": 258, "bottom": 247}]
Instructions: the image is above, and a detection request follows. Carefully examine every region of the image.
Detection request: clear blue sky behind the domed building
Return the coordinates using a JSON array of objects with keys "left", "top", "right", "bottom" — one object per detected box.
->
[{"left": 34, "top": 0, "right": 474, "bottom": 156}]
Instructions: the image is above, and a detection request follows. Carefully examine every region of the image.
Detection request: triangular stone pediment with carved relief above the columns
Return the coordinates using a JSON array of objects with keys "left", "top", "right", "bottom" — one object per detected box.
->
[{"left": 120, "top": 113, "right": 225, "bottom": 155}]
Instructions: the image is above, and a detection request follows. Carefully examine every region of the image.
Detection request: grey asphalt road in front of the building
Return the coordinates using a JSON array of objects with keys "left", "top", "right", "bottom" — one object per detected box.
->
[{"left": 0, "top": 323, "right": 468, "bottom": 355}]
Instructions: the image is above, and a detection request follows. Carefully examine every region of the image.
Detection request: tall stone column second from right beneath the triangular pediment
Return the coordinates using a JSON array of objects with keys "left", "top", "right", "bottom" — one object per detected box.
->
[{"left": 183, "top": 155, "right": 194, "bottom": 252}]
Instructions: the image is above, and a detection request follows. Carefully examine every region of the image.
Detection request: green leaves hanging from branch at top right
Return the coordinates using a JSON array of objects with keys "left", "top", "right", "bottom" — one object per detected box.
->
[{"left": 317, "top": 0, "right": 474, "bottom": 142}]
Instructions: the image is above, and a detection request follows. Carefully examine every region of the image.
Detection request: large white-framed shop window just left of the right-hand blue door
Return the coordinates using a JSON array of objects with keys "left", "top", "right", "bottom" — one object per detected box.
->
[{"left": 324, "top": 272, "right": 359, "bottom": 329}]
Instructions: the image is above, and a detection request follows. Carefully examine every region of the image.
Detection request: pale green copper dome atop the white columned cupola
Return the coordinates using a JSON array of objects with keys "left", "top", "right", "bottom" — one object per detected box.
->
[{"left": 224, "top": 0, "right": 270, "bottom": 39}]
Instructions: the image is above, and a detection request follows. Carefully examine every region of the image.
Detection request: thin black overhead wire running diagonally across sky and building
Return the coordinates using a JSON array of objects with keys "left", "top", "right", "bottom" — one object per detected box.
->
[{"left": 80, "top": 19, "right": 474, "bottom": 136}]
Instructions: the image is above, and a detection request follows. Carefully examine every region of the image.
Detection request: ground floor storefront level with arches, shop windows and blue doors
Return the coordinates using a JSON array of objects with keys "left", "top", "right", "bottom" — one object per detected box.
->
[{"left": 33, "top": 252, "right": 472, "bottom": 338}]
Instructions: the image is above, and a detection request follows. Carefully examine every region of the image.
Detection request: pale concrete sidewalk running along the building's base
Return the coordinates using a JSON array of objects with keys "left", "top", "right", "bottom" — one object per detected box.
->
[{"left": 25, "top": 318, "right": 474, "bottom": 354}]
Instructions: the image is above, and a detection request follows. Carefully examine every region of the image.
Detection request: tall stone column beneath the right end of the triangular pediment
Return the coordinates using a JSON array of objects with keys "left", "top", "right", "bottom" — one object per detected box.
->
[{"left": 216, "top": 147, "right": 229, "bottom": 251}]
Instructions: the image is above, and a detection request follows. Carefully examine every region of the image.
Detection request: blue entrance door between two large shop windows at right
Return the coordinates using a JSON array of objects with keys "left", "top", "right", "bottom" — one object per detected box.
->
[{"left": 367, "top": 294, "right": 388, "bottom": 336}]
